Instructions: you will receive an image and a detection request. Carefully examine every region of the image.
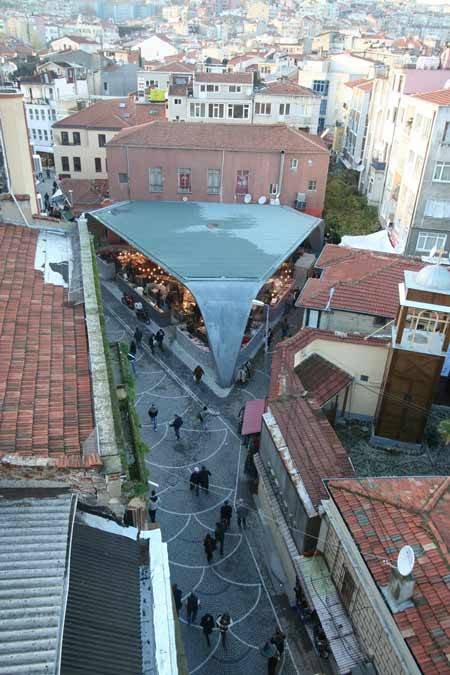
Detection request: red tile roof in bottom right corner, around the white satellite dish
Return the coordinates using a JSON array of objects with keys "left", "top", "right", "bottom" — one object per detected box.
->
[{"left": 328, "top": 477, "right": 450, "bottom": 675}]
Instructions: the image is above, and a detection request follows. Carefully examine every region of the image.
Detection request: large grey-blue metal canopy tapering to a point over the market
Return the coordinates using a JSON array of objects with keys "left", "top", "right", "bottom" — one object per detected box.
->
[{"left": 88, "top": 201, "right": 322, "bottom": 386}]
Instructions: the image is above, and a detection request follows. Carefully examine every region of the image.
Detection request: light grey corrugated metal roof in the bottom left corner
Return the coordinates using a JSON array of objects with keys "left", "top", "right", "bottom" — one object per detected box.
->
[{"left": 0, "top": 492, "right": 76, "bottom": 675}]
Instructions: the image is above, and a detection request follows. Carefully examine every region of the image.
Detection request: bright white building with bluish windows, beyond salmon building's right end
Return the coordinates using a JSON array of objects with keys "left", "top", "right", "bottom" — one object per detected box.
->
[{"left": 298, "top": 54, "right": 385, "bottom": 133}]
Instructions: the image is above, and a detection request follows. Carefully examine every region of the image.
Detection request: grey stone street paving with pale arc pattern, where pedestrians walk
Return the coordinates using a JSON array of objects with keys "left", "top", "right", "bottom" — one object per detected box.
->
[{"left": 104, "top": 291, "right": 327, "bottom": 675}]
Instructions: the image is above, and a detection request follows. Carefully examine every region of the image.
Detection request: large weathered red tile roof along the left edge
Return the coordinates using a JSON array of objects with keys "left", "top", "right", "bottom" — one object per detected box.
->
[{"left": 0, "top": 225, "right": 94, "bottom": 463}]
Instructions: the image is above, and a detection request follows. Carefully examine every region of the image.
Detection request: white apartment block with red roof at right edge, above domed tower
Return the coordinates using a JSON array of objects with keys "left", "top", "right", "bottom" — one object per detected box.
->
[{"left": 379, "top": 89, "right": 450, "bottom": 255}]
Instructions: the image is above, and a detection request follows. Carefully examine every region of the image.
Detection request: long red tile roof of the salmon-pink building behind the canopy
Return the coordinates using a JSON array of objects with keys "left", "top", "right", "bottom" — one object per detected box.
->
[{"left": 107, "top": 120, "right": 328, "bottom": 154}]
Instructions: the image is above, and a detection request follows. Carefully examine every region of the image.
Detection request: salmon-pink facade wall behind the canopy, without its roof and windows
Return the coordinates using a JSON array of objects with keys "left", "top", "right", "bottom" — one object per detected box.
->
[{"left": 107, "top": 146, "right": 328, "bottom": 216}]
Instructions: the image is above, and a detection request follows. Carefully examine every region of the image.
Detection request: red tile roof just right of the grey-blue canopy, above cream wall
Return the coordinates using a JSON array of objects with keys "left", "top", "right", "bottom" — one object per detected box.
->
[{"left": 298, "top": 244, "right": 423, "bottom": 319}]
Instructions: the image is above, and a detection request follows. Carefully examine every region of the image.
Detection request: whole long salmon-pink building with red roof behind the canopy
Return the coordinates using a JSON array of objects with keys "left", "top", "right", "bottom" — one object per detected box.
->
[{"left": 107, "top": 121, "right": 329, "bottom": 217}]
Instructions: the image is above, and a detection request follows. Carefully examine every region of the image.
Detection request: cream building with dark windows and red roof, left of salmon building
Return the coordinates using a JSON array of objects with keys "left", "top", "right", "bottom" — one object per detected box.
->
[{"left": 53, "top": 96, "right": 164, "bottom": 180}]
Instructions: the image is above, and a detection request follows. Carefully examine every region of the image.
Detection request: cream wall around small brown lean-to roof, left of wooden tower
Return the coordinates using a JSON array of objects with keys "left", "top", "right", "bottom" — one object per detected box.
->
[{"left": 295, "top": 339, "right": 389, "bottom": 418}]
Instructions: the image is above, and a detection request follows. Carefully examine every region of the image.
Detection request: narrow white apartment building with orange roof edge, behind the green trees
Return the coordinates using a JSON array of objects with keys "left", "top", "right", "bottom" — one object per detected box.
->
[{"left": 340, "top": 80, "right": 374, "bottom": 170}]
